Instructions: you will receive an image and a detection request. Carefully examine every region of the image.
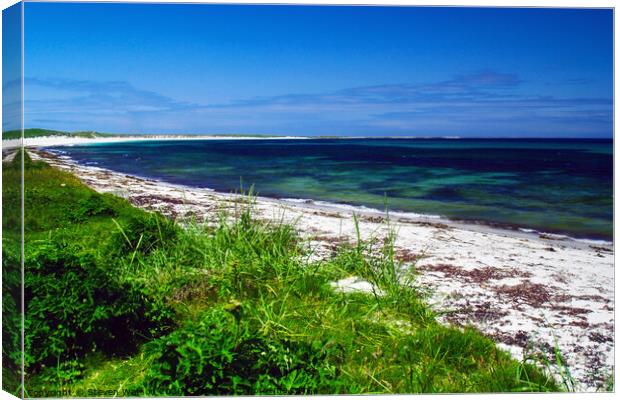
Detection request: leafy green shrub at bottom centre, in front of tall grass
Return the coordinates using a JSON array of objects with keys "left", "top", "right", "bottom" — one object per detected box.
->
[{"left": 144, "top": 307, "right": 339, "bottom": 395}]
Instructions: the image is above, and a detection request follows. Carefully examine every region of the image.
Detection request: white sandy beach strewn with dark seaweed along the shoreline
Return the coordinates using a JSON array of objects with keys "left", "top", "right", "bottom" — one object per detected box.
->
[{"left": 3, "top": 137, "right": 614, "bottom": 391}]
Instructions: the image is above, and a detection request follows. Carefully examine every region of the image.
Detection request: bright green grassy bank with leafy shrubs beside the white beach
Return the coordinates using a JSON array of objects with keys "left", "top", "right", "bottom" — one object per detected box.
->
[{"left": 3, "top": 152, "right": 559, "bottom": 397}]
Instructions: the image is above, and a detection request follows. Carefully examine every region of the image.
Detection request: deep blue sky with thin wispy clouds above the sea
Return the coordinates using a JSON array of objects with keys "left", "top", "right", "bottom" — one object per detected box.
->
[{"left": 15, "top": 3, "right": 613, "bottom": 137}]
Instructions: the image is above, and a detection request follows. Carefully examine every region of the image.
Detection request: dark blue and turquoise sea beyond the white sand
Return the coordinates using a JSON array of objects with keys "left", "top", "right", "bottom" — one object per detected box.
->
[{"left": 49, "top": 139, "right": 613, "bottom": 240}]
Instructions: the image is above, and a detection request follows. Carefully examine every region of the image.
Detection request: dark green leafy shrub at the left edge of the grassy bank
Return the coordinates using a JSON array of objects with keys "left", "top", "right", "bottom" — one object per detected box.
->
[{"left": 25, "top": 234, "right": 171, "bottom": 375}]
